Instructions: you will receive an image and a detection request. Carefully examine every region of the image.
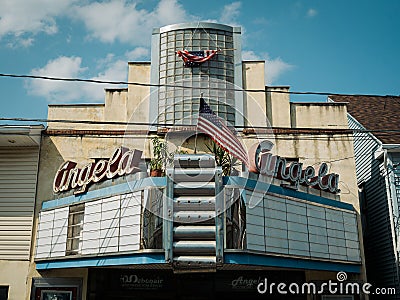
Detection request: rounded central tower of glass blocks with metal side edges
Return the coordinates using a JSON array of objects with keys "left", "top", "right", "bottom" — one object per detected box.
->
[{"left": 150, "top": 22, "right": 243, "bottom": 126}]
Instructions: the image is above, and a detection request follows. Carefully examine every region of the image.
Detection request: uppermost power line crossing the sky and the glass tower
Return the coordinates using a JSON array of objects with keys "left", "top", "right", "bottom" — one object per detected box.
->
[{"left": 0, "top": 73, "right": 400, "bottom": 98}]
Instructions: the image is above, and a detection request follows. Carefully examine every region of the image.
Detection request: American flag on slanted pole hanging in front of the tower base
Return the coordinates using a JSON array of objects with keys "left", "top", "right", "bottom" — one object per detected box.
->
[{"left": 197, "top": 98, "right": 250, "bottom": 167}]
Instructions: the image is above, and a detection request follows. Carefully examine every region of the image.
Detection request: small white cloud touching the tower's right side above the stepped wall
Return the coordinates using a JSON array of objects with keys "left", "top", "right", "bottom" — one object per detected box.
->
[{"left": 242, "top": 51, "right": 294, "bottom": 85}]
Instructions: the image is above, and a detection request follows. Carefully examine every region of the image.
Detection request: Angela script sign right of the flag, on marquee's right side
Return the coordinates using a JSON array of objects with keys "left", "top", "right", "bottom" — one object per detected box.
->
[{"left": 249, "top": 141, "right": 340, "bottom": 193}]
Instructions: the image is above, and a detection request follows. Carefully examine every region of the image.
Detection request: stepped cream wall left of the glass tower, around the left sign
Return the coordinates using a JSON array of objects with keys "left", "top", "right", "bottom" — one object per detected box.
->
[{"left": 29, "top": 64, "right": 150, "bottom": 300}]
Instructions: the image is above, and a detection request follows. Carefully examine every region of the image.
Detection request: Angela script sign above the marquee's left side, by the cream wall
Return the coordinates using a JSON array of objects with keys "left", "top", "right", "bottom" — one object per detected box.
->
[{"left": 53, "top": 147, "right": 142, "bottom": 194}]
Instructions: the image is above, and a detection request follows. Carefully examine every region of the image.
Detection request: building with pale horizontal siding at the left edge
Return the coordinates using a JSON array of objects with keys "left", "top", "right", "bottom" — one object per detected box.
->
[{"left": 0, "top": 125, "right": 44, "bottom": 299}]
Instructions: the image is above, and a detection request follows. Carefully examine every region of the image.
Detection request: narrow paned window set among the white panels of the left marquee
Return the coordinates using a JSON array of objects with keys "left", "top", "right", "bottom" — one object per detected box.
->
[{"left": 66, "top": 204, "right": 85, "bottom": 255}]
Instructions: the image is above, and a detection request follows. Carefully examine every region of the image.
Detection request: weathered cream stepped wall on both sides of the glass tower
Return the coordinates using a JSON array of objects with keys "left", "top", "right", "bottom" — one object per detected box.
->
[{"left": 31, "top": 62, "right": 368, "bottom": 296}]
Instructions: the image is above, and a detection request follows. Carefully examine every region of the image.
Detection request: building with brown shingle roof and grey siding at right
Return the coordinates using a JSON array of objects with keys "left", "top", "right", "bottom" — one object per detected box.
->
[{"left": 330, "top": 96, "right": 400, "bottom": 299}]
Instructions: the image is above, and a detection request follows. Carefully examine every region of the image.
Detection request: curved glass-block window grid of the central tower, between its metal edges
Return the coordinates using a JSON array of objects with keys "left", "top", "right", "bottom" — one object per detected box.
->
[{"left": 155, "top": 29, "right": 235, "bottom": 125}]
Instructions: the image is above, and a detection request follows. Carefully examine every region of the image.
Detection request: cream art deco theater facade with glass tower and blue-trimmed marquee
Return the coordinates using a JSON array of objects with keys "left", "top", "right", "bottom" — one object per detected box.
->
[{"left": 28, "top": 22, "right": 366, "bottom": 300}]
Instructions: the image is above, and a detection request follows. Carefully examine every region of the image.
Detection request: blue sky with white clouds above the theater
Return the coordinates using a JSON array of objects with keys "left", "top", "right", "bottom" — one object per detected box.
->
[{"left": 0, "top": 0, "right": 400, "bottom": 124}]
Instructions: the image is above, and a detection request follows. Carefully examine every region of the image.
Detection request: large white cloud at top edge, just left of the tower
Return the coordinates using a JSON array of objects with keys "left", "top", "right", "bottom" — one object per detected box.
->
[{"left": 74, "top": 0, "right": 190, "bottom": 45}]
